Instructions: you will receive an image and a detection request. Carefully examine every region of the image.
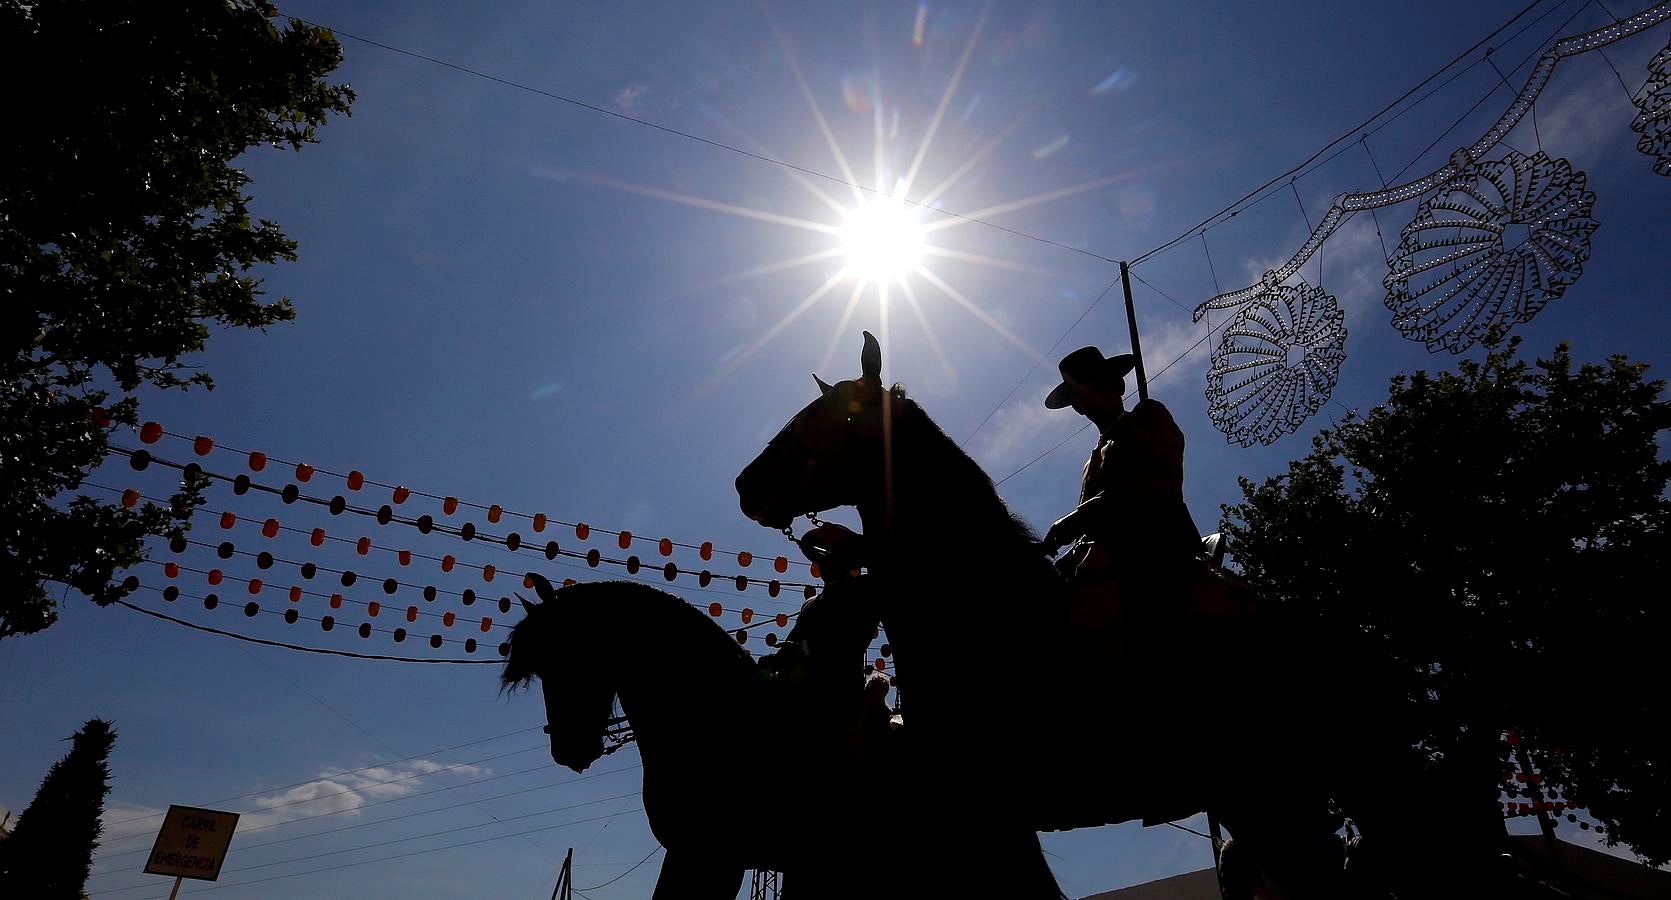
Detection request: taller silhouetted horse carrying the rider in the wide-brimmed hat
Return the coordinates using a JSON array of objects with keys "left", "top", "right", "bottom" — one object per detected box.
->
[{"left": 737, "top": 334, "right": 1383, "bottom": 895}]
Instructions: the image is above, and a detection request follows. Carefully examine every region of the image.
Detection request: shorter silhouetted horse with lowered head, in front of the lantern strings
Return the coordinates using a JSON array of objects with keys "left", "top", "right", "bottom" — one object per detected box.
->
[{"left": 501, "top": 574, "right": 1059, "bottom": 900}]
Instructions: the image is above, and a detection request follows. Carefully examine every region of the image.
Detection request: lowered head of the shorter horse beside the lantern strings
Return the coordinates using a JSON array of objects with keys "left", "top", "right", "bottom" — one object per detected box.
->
[{"left": 500, "top": 573, "right": 615, "bottom": 771}]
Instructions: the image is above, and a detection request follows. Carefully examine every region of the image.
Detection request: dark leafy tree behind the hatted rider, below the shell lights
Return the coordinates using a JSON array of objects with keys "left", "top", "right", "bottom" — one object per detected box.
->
[{"left": 1225, "top": 336, "right": 1671, "bottom": 865}]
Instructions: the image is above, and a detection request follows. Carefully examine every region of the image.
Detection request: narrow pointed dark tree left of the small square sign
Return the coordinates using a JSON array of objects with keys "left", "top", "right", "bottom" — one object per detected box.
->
[{"left": 0, "top": 718, "right": 115, "bottom": 900}]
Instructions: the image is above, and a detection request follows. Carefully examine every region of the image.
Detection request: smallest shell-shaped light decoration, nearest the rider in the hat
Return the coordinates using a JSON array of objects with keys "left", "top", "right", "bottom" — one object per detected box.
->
[{"left": 1206, "top": 282, "right": 1347, "bottom": 447}]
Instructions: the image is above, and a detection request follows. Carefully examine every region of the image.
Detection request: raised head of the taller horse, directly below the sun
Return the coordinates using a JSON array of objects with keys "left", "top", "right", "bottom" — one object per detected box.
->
[{"left": 737, "top": 332, "right": 904, "bottom": 528}]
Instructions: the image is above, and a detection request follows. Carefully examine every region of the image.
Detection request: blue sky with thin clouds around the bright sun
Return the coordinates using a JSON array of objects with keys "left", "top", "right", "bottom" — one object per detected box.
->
[{"left": 0, "top": 0, "right": 1671, "bottom": 898}]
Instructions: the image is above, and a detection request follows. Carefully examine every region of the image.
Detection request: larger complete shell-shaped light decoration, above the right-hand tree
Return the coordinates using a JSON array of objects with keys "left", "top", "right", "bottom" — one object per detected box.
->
[{"left": 1382, "top": 150, "right": 1599, "bottom": 352}]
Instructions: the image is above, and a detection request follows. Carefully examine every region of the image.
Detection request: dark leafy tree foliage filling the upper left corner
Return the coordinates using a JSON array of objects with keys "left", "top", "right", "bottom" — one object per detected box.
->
[{"left": 0, "top": 0, "right": 354, "bottom": 638}]
